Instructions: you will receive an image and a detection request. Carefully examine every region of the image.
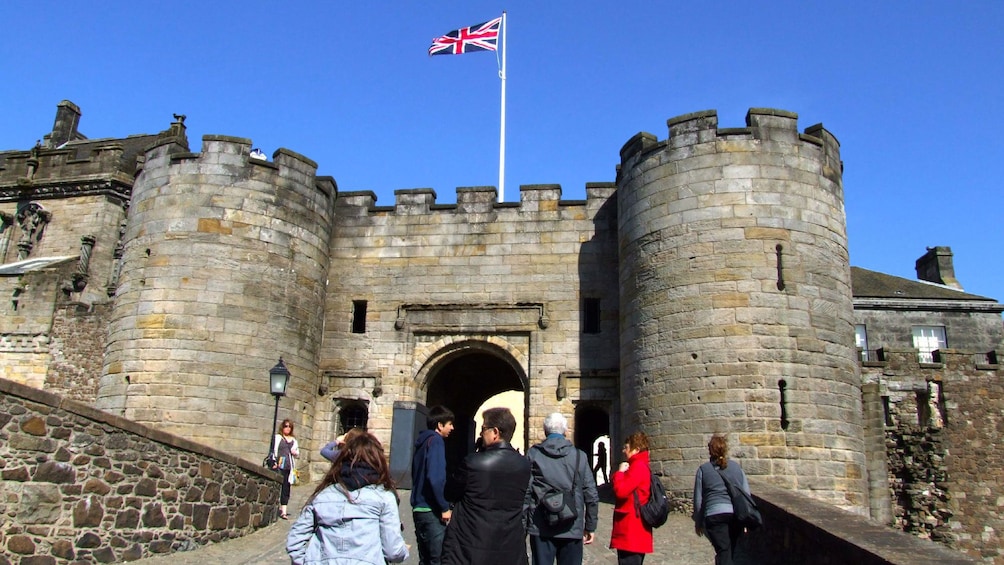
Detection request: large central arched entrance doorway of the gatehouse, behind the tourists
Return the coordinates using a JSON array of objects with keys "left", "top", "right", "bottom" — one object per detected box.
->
[{"left": 426, "top": 341, "right": 528, "bottom": 470}]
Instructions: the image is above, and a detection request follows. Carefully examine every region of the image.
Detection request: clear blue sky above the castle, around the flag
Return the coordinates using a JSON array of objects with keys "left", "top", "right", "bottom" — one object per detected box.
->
[{"left": 0, "top": 0, "right": 1004, "bottom": 300}]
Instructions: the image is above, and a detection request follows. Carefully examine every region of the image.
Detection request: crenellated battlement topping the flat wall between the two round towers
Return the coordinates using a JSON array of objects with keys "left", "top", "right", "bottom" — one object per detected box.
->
[{"left": 335, "top": 183, "right": 616, "bottom": 217}]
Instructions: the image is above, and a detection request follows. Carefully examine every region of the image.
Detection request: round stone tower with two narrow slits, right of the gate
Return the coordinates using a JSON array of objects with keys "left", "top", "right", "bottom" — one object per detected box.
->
[{"left": 617, "top": 108, "right": 867, "bottom": 512}]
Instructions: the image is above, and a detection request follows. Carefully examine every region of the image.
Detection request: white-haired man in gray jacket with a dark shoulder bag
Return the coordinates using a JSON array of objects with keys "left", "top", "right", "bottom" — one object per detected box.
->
[{"left": 526, "top": 412, "right": 599, "bottom": 565}]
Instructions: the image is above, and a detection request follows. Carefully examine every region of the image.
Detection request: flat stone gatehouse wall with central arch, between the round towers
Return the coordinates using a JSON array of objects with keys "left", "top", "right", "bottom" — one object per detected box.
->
[{"left": 325, "top": 184, "right": 618, "bottom": 459}]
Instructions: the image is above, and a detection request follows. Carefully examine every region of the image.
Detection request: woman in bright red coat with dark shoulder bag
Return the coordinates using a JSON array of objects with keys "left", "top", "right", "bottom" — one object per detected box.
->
[{"left": 610, "top": 432, "right": 652, "bottom": 565}]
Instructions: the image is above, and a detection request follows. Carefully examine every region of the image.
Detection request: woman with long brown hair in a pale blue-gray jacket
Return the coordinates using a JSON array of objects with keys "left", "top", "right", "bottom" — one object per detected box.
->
[{"left": 286, "top": 433, "right": 408, "bottom": 565}]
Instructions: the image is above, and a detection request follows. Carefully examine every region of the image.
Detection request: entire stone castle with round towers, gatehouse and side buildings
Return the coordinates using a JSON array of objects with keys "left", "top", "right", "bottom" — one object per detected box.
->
[{"left": 0, "top": 101, "right": 1004, "bottom": 562}]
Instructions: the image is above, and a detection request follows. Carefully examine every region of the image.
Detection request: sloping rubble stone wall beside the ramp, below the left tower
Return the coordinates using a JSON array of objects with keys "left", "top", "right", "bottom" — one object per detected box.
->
[{"left": 0, "top": 379, "right": 279, "bottom": 565}]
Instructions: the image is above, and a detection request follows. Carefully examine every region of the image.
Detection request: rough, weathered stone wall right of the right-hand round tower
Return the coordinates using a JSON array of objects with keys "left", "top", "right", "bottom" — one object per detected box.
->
[{"left": 861, "top": 349, "right": 1004, "bottom": 564}]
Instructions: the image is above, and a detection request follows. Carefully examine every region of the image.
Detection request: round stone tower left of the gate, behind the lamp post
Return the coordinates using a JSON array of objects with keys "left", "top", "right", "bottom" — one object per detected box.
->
[{"left": 96, "top": 135, "right": 335, "bottom": 461}]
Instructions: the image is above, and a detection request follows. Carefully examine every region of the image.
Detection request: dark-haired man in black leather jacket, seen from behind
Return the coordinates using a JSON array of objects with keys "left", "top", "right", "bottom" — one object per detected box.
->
[{"left": 443, "top": 407, "right": 530, "bottom": 565}]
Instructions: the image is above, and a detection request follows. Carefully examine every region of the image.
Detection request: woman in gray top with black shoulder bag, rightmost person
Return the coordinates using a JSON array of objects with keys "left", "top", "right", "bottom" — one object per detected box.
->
[{"left": 694, "top": 435, "right": 750, "bottom": 565}]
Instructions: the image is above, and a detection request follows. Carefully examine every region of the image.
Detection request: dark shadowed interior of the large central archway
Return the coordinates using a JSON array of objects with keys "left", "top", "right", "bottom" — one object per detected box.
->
[{"left": 427, "top": 350, "right": 523, "bottom": 472}]
